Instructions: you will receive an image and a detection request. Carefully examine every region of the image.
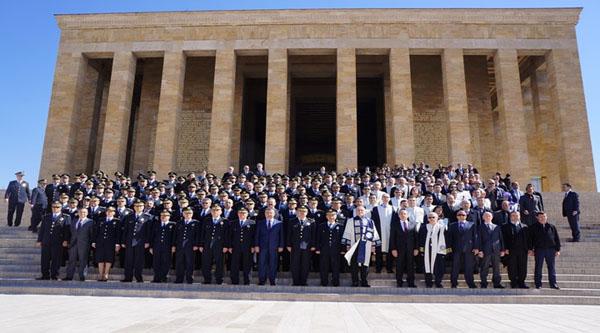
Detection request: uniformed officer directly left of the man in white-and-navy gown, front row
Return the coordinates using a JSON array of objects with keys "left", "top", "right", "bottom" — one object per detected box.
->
[{"left": 316, "top": 209, "right": 344, "bottom": 287}]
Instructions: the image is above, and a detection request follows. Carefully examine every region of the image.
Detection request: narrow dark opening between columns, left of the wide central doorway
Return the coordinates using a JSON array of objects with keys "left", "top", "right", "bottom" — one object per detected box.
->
[{"left": 240, "top": 78, "right": 267, "bottom": 166}]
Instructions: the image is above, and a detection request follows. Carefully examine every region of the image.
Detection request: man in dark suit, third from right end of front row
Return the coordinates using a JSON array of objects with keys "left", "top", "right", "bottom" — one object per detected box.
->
[{"left": 479, "top": 212, "right": 504, "bottom": 289}]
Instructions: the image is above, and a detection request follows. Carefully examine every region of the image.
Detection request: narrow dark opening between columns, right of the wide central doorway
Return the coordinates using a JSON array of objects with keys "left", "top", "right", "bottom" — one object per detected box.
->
[{"left": 356, "top": 78, "right": 385, "bottom": 170}]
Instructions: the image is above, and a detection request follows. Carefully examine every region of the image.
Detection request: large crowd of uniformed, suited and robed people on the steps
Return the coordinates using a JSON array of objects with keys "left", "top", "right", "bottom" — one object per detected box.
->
[{"left": 5, "top": 163, "right": 580, "bottom": 289}]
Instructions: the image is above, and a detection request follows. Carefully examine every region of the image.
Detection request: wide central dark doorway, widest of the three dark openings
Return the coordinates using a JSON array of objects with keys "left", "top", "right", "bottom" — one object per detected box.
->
[{"left": 290, "top": 78, "right": 336, "bottom": 173}]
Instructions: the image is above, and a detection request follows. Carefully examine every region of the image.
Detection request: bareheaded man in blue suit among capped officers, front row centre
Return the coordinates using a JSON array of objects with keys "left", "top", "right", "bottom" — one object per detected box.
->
[{"left": 254, "top": 207, "right": 285, "bottom": 286}]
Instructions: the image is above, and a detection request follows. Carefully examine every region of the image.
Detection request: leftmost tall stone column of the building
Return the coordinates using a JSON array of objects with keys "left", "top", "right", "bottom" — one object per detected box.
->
[{"left": 40, "top": 52, "right": 87, "bottom": 178}]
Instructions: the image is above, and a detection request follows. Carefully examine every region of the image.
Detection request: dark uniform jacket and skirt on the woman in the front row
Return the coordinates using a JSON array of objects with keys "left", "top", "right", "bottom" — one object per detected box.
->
[{"left": 92, "top": 218, "right": 122, "bottom": 264}]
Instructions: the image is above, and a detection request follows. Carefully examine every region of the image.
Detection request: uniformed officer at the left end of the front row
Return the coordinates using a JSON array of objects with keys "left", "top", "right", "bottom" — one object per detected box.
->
[{"left": 37, "top": 201, "right": 71, "bottom": 280}]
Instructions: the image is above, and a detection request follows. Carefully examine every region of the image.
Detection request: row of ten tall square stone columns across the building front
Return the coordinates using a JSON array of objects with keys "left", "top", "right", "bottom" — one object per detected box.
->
[{"left": 42, "top": 48, "right": 595, "bottom": 191}]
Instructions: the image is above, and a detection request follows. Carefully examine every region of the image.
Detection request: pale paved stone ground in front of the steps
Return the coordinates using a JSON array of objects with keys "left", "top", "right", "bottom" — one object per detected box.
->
[{"left": 0, "top": 295, "right": 600, "bottom": 333}]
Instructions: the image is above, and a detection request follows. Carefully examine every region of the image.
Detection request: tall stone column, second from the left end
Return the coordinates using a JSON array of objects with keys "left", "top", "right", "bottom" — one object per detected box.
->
[{"left": 100, "top": 52, "right": 137, "bottom": 175}]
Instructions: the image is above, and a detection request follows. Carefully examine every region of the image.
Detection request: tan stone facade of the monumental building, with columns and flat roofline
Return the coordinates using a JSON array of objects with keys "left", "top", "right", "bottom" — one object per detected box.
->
[{"left": 40, "top": 8, "right": 596, "bottom": 191}]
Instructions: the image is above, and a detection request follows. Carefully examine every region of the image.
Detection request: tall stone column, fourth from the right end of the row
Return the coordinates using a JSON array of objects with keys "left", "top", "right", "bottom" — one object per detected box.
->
[{"left": 386, "top": 48, "right": 415, "bottom": 164}]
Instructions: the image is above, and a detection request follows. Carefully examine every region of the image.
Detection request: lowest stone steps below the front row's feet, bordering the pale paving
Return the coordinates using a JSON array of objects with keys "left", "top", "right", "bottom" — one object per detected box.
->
[{"left": 0, "top": 280, "right": 600, "bottom": 305}]
